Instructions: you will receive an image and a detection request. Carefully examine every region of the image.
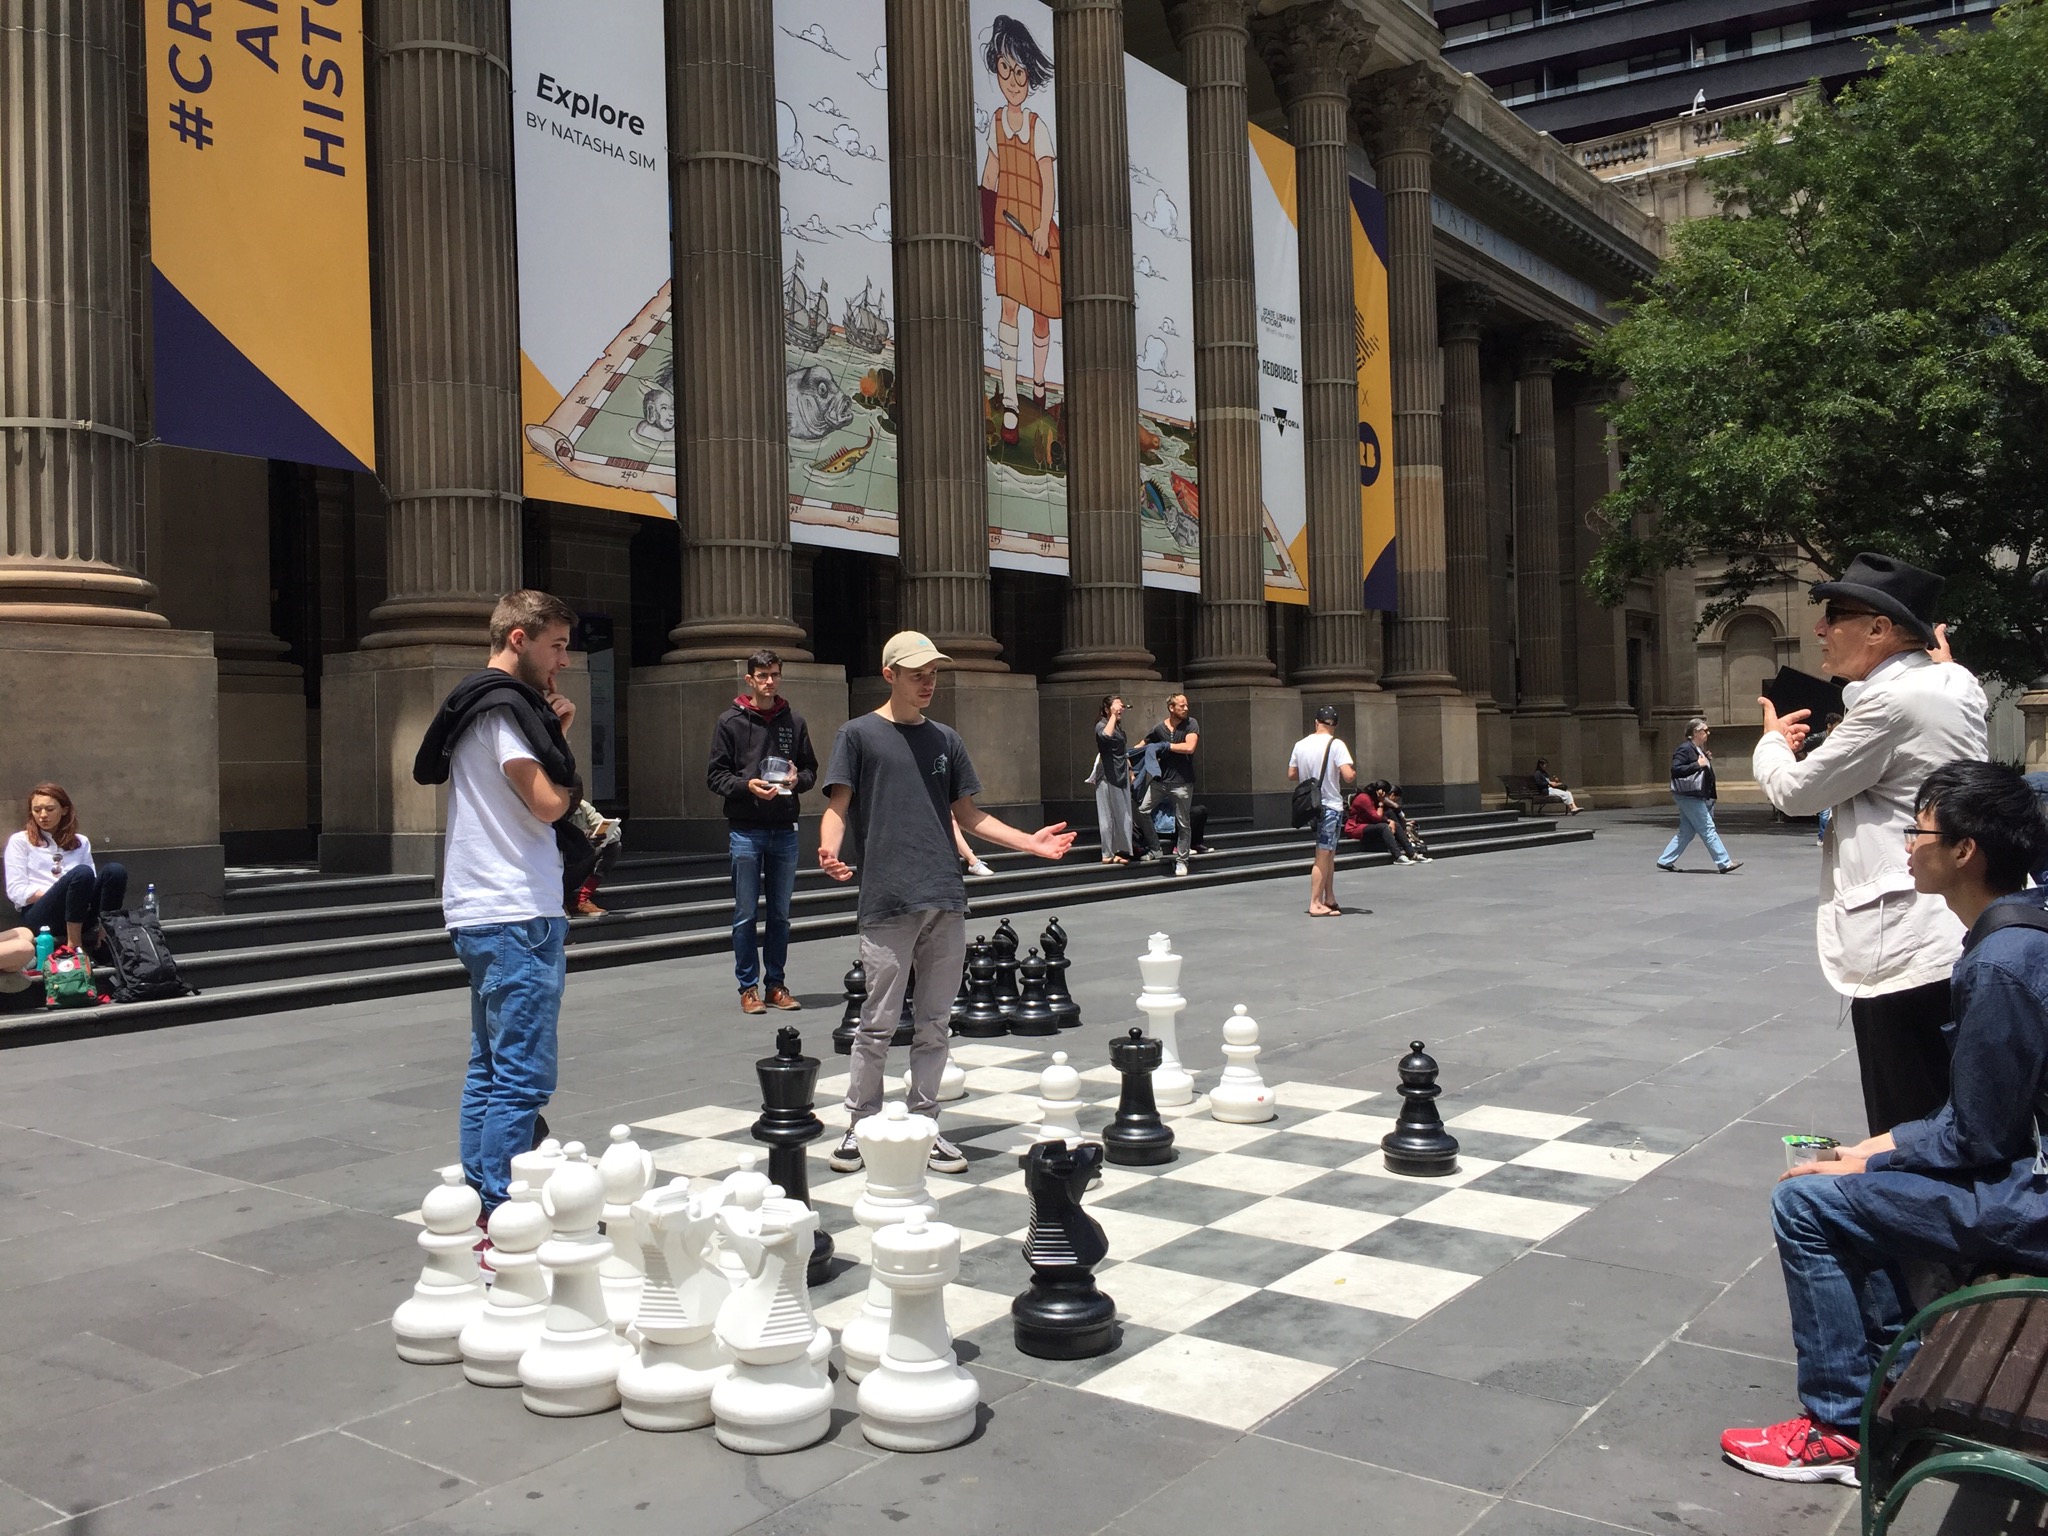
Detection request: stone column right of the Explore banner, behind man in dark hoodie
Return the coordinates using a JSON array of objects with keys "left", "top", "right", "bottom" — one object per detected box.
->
[{"left": 626, "top": 0, "right": 846, "bottom": 850}]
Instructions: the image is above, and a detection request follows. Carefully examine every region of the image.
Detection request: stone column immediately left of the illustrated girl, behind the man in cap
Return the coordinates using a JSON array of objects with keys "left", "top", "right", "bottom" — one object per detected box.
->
[{"left": 872, "top": 0, "right": 1040, "bottom": 821}]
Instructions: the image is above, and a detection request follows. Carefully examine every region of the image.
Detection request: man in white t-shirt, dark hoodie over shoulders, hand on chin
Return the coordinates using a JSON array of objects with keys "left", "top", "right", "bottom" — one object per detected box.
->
[{"left": 414, "top": 592, "right": 582, "bottom": 1217}]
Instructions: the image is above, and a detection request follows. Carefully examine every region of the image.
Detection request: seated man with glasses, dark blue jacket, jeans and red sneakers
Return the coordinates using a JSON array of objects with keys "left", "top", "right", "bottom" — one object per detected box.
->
[{"left": 1720, "top": 762, "right": 2048, "bottom": 1487}]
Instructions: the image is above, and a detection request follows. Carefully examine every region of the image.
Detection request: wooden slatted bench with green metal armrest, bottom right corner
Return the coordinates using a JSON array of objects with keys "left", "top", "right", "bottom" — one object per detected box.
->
[{"left": 1858, "top": 1276, "right": 2048, "bottom": 1536}]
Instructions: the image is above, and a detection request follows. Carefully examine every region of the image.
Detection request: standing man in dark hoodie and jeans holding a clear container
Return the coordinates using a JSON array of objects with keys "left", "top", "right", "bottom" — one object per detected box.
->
[{"left": 705, "top": 651, "right": 817, "bottom": 1014}]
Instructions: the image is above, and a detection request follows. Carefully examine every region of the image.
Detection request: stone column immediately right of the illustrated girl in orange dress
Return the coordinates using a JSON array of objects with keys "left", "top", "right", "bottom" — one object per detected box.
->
[{"left": 1038, "top": 0, "right": 1159, "bottom": 825}]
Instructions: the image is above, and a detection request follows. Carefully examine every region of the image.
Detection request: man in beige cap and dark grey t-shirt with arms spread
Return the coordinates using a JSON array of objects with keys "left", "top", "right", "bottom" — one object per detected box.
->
[{"left": 817, "top": 631, "right": 1073, "bottom": 1174}]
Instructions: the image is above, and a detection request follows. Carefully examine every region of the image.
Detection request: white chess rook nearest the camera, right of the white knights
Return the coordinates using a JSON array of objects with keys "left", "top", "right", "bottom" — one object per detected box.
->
[{"left": 856, "top": 1212, "right": 981, "bottom": 1450}]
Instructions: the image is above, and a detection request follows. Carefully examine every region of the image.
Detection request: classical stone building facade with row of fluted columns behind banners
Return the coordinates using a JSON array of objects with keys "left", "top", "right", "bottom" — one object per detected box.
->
[{"left": 0, "top": 0, "right": 1700, "bottom": 909}]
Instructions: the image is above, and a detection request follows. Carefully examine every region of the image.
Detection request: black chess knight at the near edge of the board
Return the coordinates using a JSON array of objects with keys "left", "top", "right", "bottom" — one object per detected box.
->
[{"left": 1010, "top": 1141, "right": 1122, "bottom": 1360}]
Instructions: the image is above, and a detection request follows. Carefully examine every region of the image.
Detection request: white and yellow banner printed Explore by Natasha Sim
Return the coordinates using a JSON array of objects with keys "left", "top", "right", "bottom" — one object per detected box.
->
[{"left": 512, "top": 0, "right": 676, "bottom": 516}]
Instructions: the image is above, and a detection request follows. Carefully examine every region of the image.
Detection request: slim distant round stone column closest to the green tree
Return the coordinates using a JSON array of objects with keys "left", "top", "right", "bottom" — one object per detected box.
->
[{"left": 1516, "top": 326, "right": 1569, "bottom": 776}]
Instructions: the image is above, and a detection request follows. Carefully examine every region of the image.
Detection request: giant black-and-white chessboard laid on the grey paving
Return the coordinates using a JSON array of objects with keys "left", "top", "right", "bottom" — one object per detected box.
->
[{"left": 487, "top": 1034, "right": 1692, "bottom": 1430}]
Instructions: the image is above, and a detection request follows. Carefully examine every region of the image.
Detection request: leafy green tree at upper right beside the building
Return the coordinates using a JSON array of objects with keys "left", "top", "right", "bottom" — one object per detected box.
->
[{"left": 1587, "top": 0, "right": 2048, "bottom": 684}]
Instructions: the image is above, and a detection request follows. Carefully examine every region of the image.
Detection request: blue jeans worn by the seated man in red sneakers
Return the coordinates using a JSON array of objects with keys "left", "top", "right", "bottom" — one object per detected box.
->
[{"left": 1772, "top": 1174, "right": 1907, "bottom": 1434}]
